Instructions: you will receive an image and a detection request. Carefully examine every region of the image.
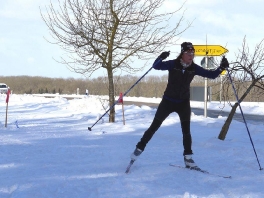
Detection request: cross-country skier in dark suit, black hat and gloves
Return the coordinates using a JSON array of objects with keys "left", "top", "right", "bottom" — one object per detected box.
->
[{"left": 131, "top": 42, "right": 229, "bottom": 170}]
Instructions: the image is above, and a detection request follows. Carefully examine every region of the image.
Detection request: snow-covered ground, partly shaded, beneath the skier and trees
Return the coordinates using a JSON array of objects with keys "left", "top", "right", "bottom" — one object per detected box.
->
[{"left": 0, "top": 94, "right": 264, "bottom": 198}]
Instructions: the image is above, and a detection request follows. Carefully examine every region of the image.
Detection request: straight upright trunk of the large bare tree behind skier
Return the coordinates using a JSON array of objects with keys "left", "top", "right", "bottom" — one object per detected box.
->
[{"left": 107, "top": 69, "right": 115, "bottom": 122}]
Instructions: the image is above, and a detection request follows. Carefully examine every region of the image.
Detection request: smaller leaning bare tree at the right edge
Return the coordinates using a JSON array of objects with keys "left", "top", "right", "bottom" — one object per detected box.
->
[{"left": 218, "top": 38, "right": 264, "bottom": 140}]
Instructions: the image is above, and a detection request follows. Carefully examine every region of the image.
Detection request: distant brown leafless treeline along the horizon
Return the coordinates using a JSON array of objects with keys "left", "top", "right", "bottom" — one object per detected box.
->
[{"left": 0, "top": 75, "right": 264, "bottom": 102}]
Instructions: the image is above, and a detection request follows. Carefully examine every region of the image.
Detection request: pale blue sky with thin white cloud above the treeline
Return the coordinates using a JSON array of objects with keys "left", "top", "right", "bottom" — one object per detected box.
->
[{"left": 0, "top": 0, "right": 264, "bottom": 78}]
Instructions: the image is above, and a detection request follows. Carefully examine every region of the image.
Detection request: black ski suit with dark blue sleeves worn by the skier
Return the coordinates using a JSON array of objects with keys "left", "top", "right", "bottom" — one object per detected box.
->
[{"left": 136, "top": 59, "right": 221, "bottom": 155}]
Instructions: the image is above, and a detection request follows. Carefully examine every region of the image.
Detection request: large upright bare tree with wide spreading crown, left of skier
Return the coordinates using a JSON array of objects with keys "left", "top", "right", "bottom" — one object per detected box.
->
[{"left": 41, "top": 0, "right": 191, "bottom": 122}]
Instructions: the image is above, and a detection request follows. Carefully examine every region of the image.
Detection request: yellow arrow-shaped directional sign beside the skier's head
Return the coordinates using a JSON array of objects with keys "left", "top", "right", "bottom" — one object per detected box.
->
[{"left": 193, "top": 45, "right": 228, "bottom": 56}]
